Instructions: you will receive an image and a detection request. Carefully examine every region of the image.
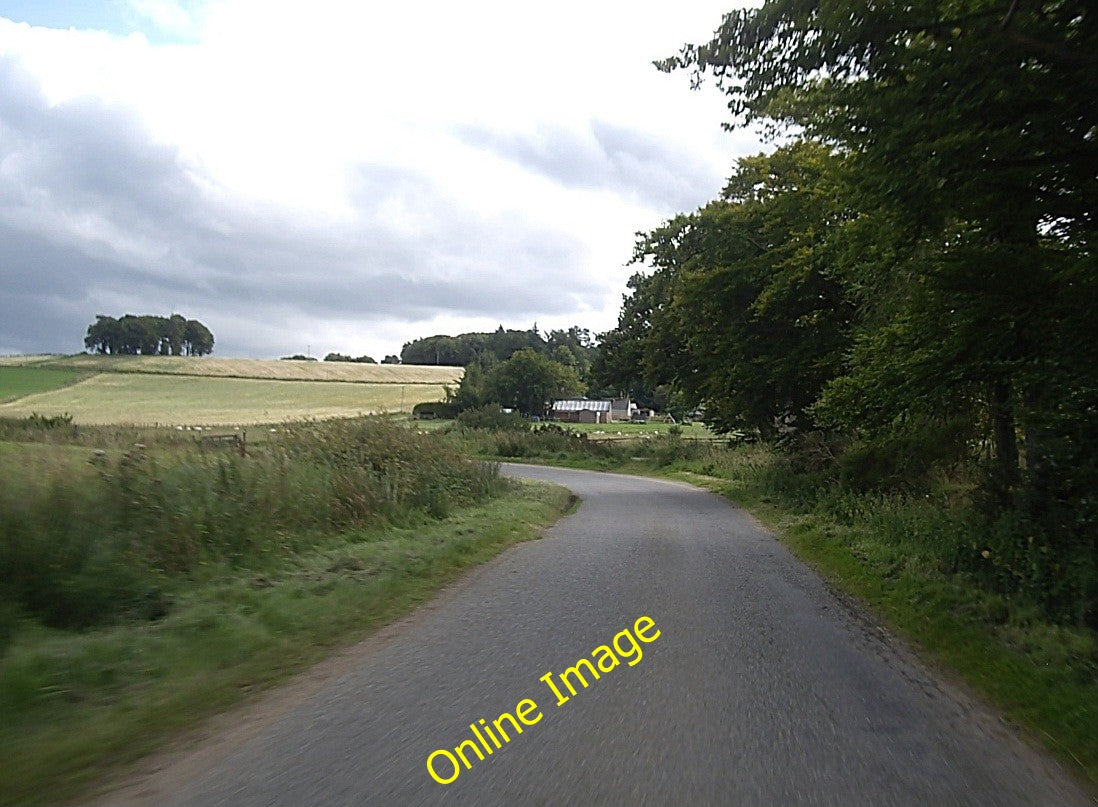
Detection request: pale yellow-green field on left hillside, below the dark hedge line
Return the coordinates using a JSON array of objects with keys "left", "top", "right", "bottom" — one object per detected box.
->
[{"left": 0, "top": 373, "right": 446, "bottom": 426}]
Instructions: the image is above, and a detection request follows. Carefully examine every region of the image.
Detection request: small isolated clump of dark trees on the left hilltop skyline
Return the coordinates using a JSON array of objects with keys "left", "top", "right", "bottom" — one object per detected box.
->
[{"left": 83, "top": 314, "right": 213, "bottom": 356}]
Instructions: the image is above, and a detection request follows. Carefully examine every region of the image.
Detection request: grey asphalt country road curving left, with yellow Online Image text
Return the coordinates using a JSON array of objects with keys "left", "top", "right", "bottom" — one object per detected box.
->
[{"left": 102, "top": 466, "right": 1093, "bottom": 807}]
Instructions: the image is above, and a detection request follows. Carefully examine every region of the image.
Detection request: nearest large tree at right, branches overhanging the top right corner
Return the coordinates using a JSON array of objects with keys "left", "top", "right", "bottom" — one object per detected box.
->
[{"left": 661, "top": 0, "right": 1098, "bottom": 491}]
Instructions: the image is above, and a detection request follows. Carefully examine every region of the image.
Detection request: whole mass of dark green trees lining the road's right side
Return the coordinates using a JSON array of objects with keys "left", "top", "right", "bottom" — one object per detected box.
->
[{"left": 596, "top": 0, "right": 1098, "bottom": 626}]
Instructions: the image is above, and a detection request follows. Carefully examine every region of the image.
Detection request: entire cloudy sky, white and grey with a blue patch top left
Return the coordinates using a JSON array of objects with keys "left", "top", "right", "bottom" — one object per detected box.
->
[{"left": 0, "top": 0, "right": 762, "bottom": 359}]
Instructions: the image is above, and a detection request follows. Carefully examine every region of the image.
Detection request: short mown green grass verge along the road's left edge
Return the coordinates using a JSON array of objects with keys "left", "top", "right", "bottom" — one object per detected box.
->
[{"left": 0, "top": 483, "right": 570, "bottom": 805}]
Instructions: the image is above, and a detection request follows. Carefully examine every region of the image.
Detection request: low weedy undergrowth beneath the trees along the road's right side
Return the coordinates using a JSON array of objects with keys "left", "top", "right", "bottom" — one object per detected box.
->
[{"left": 693, "top": 435, "right": 1098, "bottom": 628}]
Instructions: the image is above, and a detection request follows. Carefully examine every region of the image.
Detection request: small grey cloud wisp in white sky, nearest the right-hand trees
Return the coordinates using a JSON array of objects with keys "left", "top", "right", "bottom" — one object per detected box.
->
[{"left": 457, "top": 121, "right": 720, "bottom": 213}]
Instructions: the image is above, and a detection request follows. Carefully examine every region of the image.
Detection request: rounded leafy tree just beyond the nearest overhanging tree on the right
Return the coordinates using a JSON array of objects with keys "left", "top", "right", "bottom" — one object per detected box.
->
[{"left": 595, "top": 142, "right": 853, "bottom": 434}]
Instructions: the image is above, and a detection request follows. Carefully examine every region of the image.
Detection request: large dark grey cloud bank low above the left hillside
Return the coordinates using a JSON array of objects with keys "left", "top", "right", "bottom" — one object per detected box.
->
[{"left": 0, "top": 58, "right": 607, "bottom": 355}]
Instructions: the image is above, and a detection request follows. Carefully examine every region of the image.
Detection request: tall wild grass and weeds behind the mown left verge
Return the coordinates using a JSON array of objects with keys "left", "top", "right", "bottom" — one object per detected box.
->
[{"left": 0, "top": 419, "right": 505, "bottom": 641}]
